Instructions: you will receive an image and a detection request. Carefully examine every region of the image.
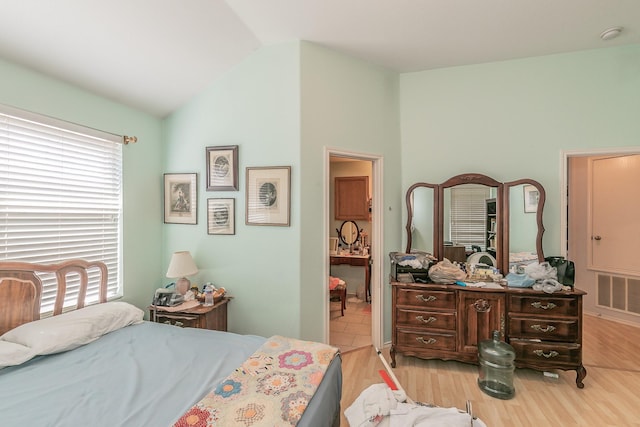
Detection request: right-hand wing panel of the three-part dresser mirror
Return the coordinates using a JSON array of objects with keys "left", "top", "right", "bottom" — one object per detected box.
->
[{"left": 502, "top": 178, "right": 546, "bottom": 272}]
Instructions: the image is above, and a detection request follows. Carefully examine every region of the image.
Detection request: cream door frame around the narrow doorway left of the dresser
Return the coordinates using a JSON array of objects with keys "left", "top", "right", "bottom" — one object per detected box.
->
[{"left": 322, "top": 147, "right": 384, "bottom": 348}]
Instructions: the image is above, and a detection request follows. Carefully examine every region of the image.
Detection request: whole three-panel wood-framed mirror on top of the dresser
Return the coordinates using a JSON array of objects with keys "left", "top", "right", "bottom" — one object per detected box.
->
[{"left": 405, "top": 174, "right": 545, "bottom": 274}]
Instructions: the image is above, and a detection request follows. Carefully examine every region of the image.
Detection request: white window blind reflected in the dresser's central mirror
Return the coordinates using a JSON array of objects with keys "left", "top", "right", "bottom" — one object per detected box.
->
[{"left": 451, "top": 184, "right": 490, "bottom": 250}]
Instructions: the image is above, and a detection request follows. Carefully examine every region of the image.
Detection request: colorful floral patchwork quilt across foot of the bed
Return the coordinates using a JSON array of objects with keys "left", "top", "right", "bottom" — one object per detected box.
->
[{"left": 174, "top": 335, "right": 338, "bottom": 427}]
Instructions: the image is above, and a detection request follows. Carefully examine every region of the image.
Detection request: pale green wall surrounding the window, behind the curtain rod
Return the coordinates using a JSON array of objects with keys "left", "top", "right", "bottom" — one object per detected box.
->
[{"left": 0, "top": 60, "right": 163, "bottom": 308}]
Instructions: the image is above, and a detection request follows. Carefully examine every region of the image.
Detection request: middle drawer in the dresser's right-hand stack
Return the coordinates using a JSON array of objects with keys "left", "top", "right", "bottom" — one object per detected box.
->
[{"left": 509, "top": 317, "right": 579, "bottom": 342}]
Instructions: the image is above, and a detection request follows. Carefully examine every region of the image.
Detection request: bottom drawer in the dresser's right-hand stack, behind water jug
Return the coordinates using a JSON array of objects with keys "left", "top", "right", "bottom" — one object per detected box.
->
[{"left": 509, "top": 339, "right": 582, "bottom": 366}]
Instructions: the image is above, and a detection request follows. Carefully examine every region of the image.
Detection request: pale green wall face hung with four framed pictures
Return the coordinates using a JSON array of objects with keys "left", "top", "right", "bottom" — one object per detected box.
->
[{"left": 163, "top": 43, "right": 302, "bottom": 337}]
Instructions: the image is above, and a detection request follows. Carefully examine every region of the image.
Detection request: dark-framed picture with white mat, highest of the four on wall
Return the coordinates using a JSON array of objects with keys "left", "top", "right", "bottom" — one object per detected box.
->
[{"left": 206, "top": 145, "right": 238, "bottom": 191}]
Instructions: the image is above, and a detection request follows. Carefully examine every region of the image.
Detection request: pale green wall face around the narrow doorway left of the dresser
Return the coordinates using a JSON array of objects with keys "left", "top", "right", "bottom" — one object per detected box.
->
[{"left": 300, "top": 43, "right": 401, "bottom": 340}]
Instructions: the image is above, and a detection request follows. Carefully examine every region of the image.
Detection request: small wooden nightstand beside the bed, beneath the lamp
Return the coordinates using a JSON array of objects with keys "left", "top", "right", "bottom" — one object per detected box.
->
[{"left": 149, "top": 298, "right": 230, "bottom": 332}]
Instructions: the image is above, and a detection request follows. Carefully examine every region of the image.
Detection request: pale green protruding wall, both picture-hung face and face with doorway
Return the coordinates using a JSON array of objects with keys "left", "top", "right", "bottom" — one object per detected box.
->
[{"left": 164, "top": 42, "right": 400, "bottom": 340}]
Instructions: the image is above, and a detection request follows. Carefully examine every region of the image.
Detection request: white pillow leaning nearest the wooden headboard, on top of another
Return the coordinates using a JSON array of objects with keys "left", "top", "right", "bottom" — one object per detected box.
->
[{"left": 0, "top": 301, "right": 144, "bottom": 354}]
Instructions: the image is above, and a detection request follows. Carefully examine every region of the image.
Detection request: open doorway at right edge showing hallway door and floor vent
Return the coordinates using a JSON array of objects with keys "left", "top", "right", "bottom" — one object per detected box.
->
[{"left": 561, "top": 148, "right": 640, "bottom": 326}]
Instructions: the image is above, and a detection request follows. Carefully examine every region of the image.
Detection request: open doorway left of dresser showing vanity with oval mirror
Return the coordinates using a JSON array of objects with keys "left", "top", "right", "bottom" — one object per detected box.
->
[{"left": 324, "top": 149, "right": 382, "bottom": 352}]
